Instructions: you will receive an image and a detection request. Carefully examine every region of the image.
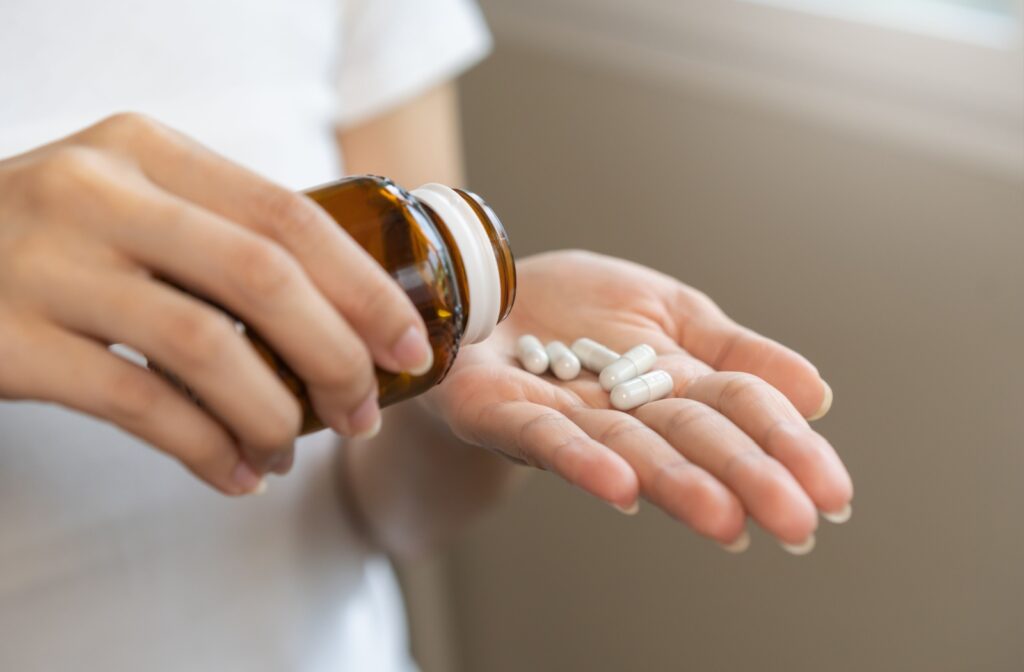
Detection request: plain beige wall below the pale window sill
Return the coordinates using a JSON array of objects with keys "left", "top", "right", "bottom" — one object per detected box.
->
[{"left": 403, "top": 27, "right": 1024, "bottom": 672}]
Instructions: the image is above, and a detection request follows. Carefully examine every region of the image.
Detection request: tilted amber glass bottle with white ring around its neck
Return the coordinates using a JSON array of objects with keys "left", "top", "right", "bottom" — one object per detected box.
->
[{"left": 220, "top": 175, "right": 515, "bottom": 433}]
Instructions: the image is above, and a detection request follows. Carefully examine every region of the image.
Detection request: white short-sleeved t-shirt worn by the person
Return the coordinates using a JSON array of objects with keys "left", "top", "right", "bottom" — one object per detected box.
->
[{"left": 0, "top": 0, "right": 489, "bottom": 672}]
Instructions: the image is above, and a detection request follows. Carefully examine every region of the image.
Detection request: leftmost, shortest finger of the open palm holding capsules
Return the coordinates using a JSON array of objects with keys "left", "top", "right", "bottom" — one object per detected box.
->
[{"left": 471, "top": 401, "right": 637, "bottom": 509}]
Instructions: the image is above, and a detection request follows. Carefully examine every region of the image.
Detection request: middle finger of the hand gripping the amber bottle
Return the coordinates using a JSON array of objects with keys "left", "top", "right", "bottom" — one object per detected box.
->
[{"left": 102, "top": 182, "right": 380, "bottom": 435}]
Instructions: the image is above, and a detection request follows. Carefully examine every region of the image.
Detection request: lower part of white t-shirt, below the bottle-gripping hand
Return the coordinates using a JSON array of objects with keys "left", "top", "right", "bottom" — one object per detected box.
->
[{"left": 0, "top": 403, "right": 407, "bottom": 672}]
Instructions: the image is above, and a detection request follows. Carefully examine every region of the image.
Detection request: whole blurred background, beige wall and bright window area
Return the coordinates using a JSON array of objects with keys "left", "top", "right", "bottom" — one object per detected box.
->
[{"left": 402, "top": 0, "right": 1024, "bottom": 672}]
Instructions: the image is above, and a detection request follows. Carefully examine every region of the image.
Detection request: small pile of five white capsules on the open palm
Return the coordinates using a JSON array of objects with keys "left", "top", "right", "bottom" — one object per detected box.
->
[{"left": 515, "top": 334, "right": 673, "bottom": 411}]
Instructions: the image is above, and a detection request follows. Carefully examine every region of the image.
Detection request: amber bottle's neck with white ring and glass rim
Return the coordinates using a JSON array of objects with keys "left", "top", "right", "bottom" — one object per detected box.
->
[{"left": 412, "top": 183, "right": 515, "bottom": 344}]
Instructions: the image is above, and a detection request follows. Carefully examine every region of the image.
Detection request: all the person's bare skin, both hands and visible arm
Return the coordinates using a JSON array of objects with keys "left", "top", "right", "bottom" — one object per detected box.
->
[{"left": 0, "top": 85, "right": 852, "bottom": 554}]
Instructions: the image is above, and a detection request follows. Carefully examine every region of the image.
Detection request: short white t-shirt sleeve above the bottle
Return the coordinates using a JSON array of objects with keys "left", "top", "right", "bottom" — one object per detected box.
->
[{"left": 336, "top": 0, "right": 492, "bottom": 128}]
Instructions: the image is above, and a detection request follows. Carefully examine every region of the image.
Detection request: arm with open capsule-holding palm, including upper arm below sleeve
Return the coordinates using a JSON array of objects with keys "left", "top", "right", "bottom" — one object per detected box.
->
[{"left": 340, "top": 86, "right": 853, "bottom": 556}]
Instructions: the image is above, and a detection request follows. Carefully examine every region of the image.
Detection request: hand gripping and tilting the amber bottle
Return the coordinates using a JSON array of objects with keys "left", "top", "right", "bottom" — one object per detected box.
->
[{"left": 0, "top": 115, "right": 430, "bottom": 494}]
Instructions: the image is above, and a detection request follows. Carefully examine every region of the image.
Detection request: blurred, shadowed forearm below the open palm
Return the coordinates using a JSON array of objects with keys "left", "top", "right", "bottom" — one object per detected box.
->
[{"left": 341, "top": 402, "right": 525, "bottom": 556}]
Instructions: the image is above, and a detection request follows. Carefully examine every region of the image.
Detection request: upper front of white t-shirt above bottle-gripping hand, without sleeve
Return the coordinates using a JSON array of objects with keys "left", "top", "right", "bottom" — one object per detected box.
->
[{"left": 0, "top": 0, "right": 343, "bottom": 188}]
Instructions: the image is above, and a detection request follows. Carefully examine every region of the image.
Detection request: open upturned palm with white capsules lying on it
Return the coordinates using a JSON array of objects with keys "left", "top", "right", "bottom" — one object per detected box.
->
[{"left": 419, "top": 252, "right": 853, "bottom": 552}]
